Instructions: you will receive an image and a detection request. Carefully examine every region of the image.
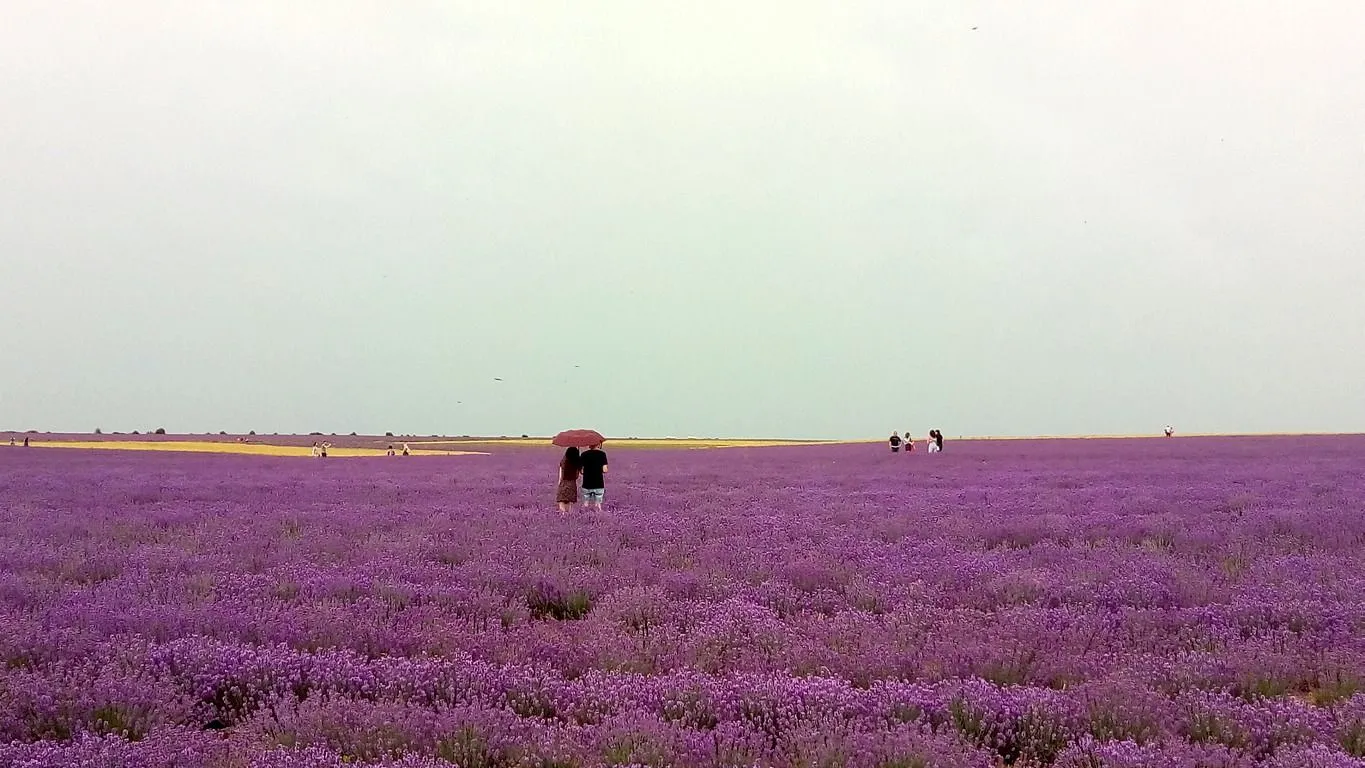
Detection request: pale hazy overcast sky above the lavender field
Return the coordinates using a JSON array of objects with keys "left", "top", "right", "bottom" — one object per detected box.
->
[{"left": 0, "top": 0, "right": 1365, "bottom": 437}]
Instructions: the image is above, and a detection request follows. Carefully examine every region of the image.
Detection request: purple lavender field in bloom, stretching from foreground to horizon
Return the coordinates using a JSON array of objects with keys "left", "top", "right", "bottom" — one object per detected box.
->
[{"left": 0, "top": 437, "right": 1365, "bottom": 768}]
